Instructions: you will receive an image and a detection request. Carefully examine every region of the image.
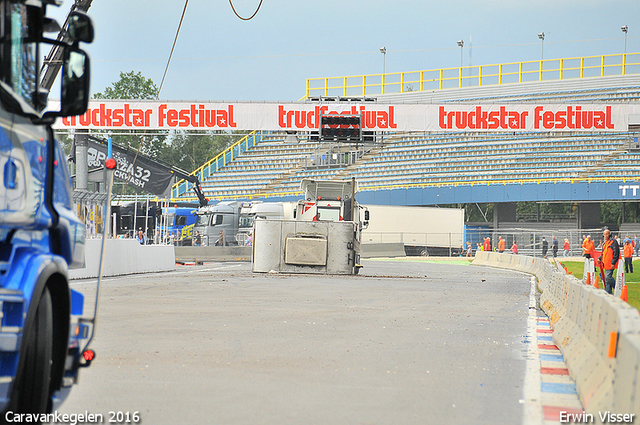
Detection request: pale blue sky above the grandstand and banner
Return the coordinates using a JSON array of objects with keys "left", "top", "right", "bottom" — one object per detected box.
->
[{"left": 49, "top": 0, "right": 640, "bottom": 102}]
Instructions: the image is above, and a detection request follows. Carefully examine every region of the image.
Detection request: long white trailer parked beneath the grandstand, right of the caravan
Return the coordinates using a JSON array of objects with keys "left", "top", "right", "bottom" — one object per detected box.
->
[{"left": 362, "top": 205, "right": 464, "bottom": 255}]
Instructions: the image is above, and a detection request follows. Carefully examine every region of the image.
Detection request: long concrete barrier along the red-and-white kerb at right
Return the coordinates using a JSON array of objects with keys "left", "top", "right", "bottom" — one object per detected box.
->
[{"left": 472, "top": 251, "right": 640, "bottom": 416}]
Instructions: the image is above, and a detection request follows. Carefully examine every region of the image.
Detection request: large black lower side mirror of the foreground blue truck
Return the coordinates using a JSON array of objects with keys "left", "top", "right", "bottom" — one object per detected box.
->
[{"left": 59, "top": 49, "right": 89, "bottom": 117}]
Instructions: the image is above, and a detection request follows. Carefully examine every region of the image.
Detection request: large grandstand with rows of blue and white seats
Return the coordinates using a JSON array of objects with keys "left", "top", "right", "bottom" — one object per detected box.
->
[{"left": 172, "top": 54, "right": 640, "bottom": 222}]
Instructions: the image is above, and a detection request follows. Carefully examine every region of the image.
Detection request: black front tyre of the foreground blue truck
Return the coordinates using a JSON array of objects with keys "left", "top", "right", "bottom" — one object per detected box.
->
[{"left": 13, "top": 287, "right": 53, "bottom": 413}]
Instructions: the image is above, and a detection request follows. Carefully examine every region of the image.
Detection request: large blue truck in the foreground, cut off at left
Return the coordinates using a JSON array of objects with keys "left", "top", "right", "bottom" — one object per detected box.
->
[{"left": 0, "top": 0, "right": 95, "bottom": 422}]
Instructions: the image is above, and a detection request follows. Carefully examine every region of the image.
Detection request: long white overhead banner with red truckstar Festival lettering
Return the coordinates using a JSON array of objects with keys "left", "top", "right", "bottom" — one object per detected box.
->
[{"left": 54, "top": 100, "right": 640, "bottom": 132}]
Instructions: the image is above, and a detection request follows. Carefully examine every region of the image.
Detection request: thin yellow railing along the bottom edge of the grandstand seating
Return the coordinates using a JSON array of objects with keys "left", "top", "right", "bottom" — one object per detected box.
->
[{"left": 171, "top": 177, "right": 638, "bottom": 202}]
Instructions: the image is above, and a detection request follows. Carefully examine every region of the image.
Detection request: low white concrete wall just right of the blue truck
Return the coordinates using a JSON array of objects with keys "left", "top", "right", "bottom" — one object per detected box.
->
[{"left": 69, "top": 239, "right": 176, "bottom": 279}]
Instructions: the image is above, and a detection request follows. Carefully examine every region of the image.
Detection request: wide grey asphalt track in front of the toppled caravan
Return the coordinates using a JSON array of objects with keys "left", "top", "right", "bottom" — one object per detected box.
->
[{"left": 58, "top": 260, "right": 531, "bottom": 425}]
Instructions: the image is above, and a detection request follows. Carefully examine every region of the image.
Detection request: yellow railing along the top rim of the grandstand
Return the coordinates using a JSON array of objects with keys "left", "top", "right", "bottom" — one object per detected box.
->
[{"left": 304, "top": 53, "right": 640, "bottom": 99}]
